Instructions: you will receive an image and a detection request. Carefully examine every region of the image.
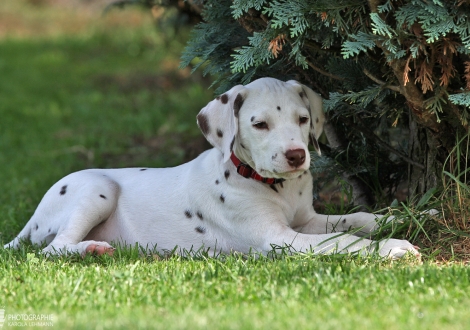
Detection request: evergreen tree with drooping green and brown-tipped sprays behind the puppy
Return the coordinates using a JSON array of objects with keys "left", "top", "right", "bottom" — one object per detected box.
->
[{"left": 178, "top": 0, "right": 470, "bottom": 205}]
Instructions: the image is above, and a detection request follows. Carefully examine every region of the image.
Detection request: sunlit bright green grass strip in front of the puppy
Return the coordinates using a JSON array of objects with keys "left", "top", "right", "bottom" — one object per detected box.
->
[{"left": 0, "top": 251, "right": 470, "bottom": 330}]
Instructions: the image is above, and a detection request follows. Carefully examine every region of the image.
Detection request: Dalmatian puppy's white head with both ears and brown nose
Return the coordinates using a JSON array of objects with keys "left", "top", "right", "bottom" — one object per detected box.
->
[{"left": 197, "top": 78, "right": 325, "bottom": 179}]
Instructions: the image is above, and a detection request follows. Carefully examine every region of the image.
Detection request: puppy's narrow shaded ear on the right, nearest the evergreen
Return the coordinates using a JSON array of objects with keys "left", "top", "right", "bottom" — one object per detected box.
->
[{"left": 287, "top": 80, "right": 325, "bottom": 155}]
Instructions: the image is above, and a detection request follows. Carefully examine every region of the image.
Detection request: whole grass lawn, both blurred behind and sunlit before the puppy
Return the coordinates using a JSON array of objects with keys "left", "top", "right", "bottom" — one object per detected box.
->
[{"left": 0, "top": 1, "right": 470, "bottom": 329}]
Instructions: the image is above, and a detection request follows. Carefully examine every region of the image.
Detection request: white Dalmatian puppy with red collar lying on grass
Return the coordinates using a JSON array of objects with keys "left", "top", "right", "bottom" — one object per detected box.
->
[{"left": 5, "top": 78, "right": 419, "bottom": 258}]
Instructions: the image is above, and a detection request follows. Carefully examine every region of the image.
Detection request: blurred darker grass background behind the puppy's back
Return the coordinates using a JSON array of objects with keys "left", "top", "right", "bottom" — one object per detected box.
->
[{"left": 0, "top": 0, "right": 212, "bottom": 240}]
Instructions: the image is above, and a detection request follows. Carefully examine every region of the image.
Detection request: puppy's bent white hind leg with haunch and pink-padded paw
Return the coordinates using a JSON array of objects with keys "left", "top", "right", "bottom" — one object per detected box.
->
[{"left": 5, "top": 171, "right": 119, "bottom": 254}]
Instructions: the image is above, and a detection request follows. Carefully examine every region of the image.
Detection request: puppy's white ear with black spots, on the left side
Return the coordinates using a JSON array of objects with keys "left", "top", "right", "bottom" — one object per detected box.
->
[{"left": 197, "top": 85, "right": 247, "bottom": 162}]
